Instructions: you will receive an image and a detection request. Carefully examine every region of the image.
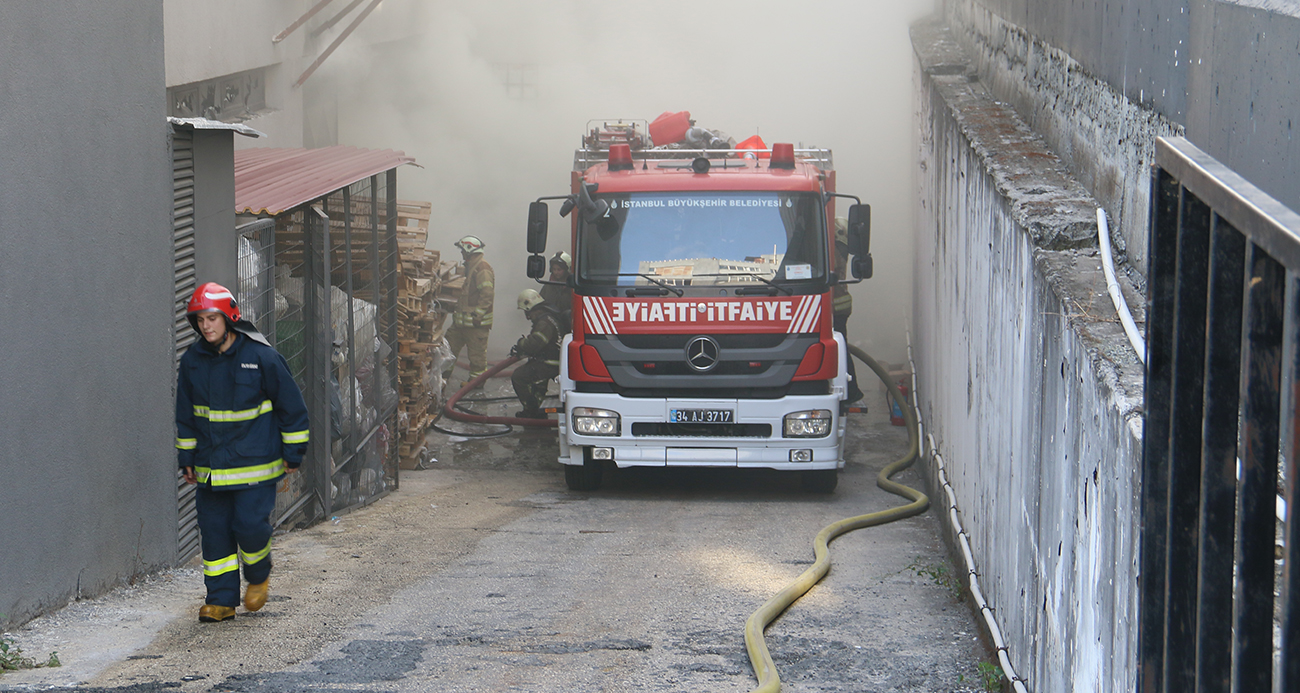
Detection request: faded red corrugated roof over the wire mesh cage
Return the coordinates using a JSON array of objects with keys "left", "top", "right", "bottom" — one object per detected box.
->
[{"left": 235, "top": 144, "right": 415, "bottom": 216}]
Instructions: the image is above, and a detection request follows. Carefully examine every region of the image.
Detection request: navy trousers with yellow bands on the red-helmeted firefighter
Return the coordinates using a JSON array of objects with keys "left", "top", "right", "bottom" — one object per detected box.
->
[{"left": 194, "top": 484, "right": 276, "bottom": 607}]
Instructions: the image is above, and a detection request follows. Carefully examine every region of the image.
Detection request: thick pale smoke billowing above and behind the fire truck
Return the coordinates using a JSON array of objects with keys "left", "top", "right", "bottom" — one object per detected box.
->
[{"left": 338, "top": 0, "right": 931, "bottom": 363}]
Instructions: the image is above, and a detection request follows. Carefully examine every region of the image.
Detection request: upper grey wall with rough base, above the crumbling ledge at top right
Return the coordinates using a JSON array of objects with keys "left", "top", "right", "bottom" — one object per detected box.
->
[{"left": 945, "top": 0, "right": 1300, "bottom": 280}]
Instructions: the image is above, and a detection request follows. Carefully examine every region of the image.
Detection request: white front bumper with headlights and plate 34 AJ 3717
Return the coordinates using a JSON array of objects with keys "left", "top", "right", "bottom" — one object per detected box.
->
[{"left": 559, "top": 391, "right": 845, "bottom": 471}]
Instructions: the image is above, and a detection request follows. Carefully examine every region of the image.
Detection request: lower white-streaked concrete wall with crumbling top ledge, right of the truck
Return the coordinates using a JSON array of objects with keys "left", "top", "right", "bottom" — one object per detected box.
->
[{"left": 913, "top": 18, "right": 1143, "bottom": 692}]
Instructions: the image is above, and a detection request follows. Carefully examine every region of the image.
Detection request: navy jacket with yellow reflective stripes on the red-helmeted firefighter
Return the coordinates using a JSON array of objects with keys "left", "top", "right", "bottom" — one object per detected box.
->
[{"left": 176, "top": 333, "right": 308, "bottom": 490}]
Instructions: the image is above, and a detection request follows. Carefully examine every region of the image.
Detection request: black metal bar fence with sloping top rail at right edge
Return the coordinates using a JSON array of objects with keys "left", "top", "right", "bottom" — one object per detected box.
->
[{"left": 1138, "top": 138, "right": 1300, "bottom": 693}]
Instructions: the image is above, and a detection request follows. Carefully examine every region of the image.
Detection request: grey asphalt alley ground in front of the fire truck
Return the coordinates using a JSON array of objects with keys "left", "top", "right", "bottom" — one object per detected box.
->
[{"left": 0, "top": 381, "right": 989, "bottom": 693}]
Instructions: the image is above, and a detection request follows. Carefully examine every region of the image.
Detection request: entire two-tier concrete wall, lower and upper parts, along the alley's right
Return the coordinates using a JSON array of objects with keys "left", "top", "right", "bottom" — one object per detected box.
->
[{"left": 914, "top": 0, "right": 1300, "bottom": 690}]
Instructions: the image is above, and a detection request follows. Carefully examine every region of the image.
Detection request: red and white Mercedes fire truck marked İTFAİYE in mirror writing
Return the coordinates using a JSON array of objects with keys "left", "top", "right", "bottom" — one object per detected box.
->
[{"left": 528, "top": 122, "right": 871, "bottom": 493}]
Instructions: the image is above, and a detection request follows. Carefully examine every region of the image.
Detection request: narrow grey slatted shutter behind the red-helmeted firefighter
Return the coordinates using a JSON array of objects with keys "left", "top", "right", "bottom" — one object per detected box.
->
[{"left": 172, "top": 127, "right": 199, "bottom": 563}]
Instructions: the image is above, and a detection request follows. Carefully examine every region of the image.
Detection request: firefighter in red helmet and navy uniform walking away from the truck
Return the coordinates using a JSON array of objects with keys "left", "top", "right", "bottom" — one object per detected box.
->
[{"left": 176, "top": 282, "right": 308, "bottom": 623}]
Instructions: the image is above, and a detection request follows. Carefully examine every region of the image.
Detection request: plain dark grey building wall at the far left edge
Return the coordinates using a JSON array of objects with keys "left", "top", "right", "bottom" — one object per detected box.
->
[{"left": 0, "top": 0, "right": 177, "bottom": 628}]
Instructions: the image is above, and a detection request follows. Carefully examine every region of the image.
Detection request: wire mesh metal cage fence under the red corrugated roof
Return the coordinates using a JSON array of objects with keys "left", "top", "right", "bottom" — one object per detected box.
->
[{"left": 238, "top": 170, "right": 398, "bottom": 527}]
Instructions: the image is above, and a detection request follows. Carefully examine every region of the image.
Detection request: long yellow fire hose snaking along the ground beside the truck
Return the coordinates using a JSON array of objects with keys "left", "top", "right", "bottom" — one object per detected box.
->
[{"left": 745, "top": 346, "right": 930, "bottom": 693}]
